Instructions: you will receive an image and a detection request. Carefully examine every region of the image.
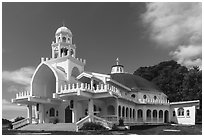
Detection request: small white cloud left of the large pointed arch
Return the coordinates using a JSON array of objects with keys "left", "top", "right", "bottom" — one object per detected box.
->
[{"left": 2, "top": 67, "right": 35, "bottom": 86}]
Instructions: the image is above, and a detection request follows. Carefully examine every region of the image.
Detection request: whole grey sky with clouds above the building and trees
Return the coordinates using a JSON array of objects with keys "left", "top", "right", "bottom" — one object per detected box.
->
[{"left": 2, "top": 2, "right": 202, "bottom": 119}]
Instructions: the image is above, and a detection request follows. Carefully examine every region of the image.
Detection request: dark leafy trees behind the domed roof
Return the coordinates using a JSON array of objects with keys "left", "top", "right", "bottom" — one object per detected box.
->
[{"left": 134, "top": 60, "right": 202, "bottom": 120}]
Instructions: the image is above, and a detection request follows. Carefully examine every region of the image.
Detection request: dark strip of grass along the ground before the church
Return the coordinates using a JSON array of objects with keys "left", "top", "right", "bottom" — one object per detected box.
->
[{"left": 2, "top": 124, "right": 202, "bottom": 135}]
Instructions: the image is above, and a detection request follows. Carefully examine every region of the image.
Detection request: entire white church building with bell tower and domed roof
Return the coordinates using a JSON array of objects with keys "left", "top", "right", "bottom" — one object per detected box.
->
[{"left": 12, "top": 26, "right": 199, "bottom": 130}]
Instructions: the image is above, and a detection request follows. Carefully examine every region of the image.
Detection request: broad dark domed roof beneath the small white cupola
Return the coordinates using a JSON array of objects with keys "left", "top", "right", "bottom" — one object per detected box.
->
[{"left": 110, "top": 73, "right": 161, "bottom": 92}]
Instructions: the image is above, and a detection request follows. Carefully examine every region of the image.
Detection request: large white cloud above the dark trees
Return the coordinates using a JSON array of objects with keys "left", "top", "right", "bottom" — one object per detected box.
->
[{"left": 141, "top": 2, "right": 202, "bottom": 67}]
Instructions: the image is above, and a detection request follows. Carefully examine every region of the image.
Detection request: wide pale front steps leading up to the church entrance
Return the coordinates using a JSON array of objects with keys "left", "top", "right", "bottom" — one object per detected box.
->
[{"left": 19, "top": 123, "right": 77, "bottom": 131}]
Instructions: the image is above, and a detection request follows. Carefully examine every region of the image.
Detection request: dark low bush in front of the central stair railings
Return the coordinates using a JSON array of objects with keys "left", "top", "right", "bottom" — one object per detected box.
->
[{"left": 80, "top": 122, "right": 106, "bottom": 130}]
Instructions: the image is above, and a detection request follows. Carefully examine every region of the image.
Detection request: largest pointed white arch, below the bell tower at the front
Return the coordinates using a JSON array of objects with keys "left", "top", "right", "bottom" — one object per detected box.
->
[{"left": 31, "top": 63, "right": 58, "bottom": 97}]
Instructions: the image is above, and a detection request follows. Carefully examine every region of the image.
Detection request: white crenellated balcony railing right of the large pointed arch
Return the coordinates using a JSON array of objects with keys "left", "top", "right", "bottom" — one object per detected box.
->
[{"left": 58, "top": 83, "right": 121, "bottom": 96}]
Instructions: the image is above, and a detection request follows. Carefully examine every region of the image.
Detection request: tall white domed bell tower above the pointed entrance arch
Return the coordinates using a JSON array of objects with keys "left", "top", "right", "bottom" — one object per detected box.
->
[{"left": 51, "top": 26, "right": 76, "bottom": 58}]
